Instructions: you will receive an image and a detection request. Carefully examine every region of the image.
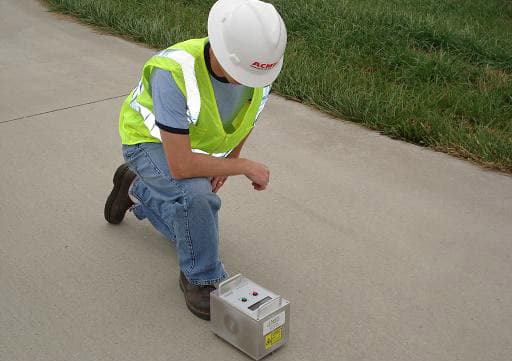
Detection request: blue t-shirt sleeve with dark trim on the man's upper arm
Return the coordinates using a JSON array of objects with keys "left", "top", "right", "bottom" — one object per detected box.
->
[{"left": 150, "top": 68, "right": 189, "bottom": 134}]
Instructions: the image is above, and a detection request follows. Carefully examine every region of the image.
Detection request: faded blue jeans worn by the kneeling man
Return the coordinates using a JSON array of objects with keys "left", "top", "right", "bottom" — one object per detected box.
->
[{"left": 123, "top": 143, "right": 227, "bottom": 285}]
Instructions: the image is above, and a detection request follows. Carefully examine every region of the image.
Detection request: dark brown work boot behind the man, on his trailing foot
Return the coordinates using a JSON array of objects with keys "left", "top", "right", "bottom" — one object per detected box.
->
[{"left": 104, "top": 164, "right": 136, "bottom": 224}]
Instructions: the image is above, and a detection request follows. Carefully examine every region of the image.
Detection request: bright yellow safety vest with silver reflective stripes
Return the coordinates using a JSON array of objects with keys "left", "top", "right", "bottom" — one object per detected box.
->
[{"left": 119, "top": 38, "right": 270, "bottom": 157}]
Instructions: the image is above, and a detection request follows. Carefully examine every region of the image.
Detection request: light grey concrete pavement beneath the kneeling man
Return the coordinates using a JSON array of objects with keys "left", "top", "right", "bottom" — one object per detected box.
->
[{"left": 0, "top": 0, "right": 512, "bottom": 361}]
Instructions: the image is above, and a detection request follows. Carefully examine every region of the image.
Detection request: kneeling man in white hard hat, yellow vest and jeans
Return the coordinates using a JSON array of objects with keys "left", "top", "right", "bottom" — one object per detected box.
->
[{"left": 105, "top": 0, "right": 286, "bottom": 320}]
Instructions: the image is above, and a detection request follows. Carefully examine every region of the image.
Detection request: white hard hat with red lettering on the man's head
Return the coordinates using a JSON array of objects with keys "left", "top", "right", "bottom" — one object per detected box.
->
[{"left": 208, "top": 0, "right": 286, "bottom": 88}]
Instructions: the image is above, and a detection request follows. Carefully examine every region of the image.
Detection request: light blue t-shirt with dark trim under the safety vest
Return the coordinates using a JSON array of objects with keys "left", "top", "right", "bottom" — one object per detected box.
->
[{"left": 150, "top": 44, "right": 260, "bottom": 134}]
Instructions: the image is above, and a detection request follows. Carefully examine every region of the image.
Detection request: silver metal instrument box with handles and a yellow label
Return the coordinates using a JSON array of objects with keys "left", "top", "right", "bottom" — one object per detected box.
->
[{"left": 210, "top": 274, "right": 290, "bottom": 360}]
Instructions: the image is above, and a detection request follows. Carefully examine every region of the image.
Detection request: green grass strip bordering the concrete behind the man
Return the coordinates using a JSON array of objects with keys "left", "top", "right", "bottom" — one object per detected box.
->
[{"left": 47, "top": 0, "right": 512, "bottom": 173}]
